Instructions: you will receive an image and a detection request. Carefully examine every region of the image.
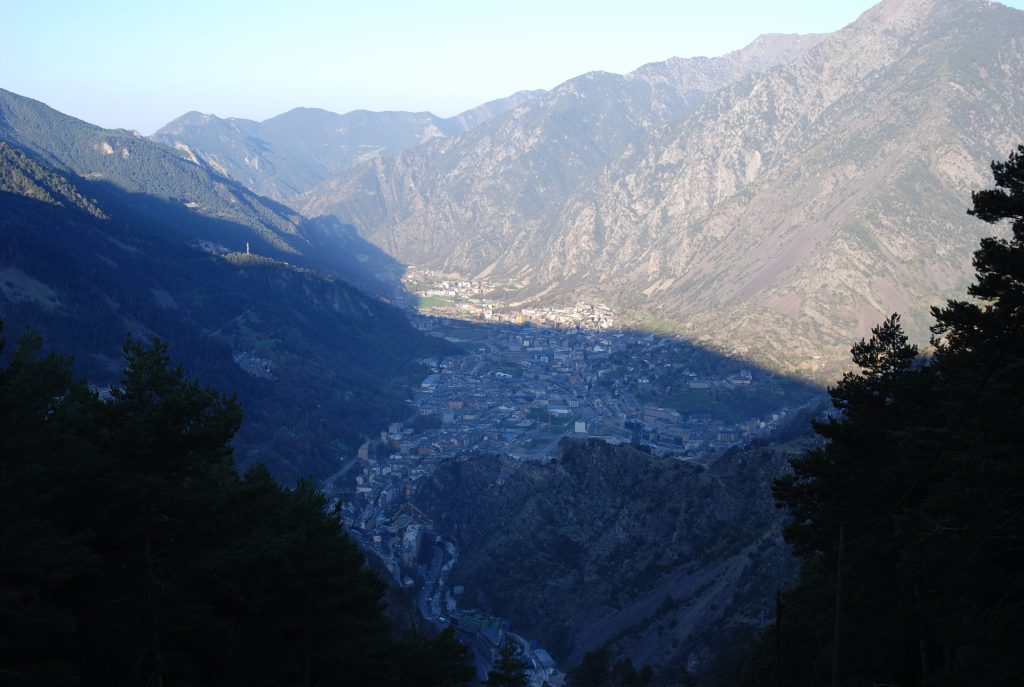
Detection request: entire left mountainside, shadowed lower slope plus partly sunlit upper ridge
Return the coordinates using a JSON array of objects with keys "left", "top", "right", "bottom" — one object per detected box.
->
[{"left": 0, "top": 91, "right": 450, "bottom": 481}]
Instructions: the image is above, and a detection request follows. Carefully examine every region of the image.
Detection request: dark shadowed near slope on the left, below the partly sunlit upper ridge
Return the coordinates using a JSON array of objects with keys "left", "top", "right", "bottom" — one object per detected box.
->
[{"left": 0, "top": 142, "right": 448, "bottom": 482}]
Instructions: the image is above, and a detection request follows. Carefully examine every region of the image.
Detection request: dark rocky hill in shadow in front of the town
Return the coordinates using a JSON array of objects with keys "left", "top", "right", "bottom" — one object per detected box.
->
[{"left": 416, "top": 440, "right": 804, "bottom": 669}]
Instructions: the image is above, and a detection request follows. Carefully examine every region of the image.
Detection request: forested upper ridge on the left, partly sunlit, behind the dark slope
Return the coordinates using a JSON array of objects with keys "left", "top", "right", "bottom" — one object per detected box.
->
[{"left": 0, "top": 89, "right": 396, "bottom": 292}]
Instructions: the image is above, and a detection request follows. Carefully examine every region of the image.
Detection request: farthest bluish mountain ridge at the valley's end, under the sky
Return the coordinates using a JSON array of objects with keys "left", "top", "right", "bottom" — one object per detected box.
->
[{"left": 153, "top": 91, "right": 544, "bottom": 200}]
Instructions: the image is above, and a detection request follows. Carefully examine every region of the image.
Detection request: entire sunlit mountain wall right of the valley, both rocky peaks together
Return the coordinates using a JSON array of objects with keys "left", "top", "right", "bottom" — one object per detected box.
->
[{"left": 298, "top": 0, "right": 1024, "bottom": 375}]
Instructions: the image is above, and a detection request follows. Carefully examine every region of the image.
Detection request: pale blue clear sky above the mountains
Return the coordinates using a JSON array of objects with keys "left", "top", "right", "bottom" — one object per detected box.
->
[{"left": 6, "top": 0, "right": 1024, "bottom": 134}]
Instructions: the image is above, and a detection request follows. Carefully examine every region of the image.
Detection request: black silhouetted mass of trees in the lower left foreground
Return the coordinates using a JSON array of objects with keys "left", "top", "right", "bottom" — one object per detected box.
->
[{"left": 0, "top": 335, "right": 473, "bottom": 685}]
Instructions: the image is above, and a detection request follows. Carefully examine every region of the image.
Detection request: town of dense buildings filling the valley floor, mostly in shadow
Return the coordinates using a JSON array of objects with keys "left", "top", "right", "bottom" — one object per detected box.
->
[{"left": 327, "top": 278, "right": 815, "bottom": 687}]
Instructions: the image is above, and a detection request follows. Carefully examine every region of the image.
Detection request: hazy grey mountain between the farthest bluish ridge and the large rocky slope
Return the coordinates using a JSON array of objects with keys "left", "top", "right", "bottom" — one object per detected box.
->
[{"left": 294, "top": 36, "right": 818, "bottom": 274}]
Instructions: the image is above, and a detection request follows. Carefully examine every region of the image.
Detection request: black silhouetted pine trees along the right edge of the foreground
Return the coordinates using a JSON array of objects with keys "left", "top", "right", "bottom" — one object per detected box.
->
[{"left": 751, "top": 146, "right": 1024, "bottom": 685}]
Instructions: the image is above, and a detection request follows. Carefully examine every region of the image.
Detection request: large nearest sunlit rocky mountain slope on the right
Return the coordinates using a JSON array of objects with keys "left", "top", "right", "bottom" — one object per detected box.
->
[{"left": 536, "top": 0, "right": 1024, "bottom": 371}]
